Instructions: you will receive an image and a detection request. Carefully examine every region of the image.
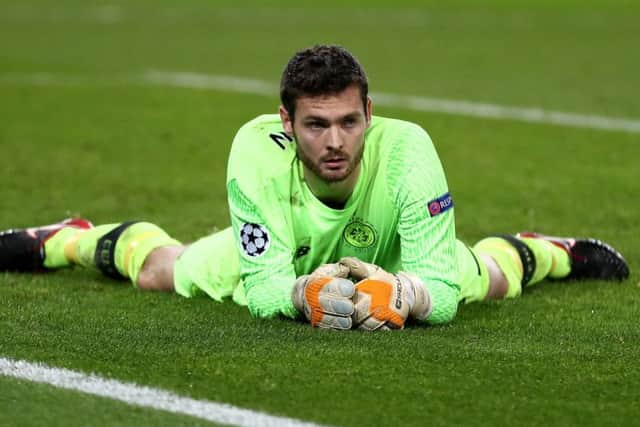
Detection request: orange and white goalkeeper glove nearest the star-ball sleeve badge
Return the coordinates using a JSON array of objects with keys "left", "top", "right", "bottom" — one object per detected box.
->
[{"left": 291, "top": 263, "right": 355, "bottom": 329}]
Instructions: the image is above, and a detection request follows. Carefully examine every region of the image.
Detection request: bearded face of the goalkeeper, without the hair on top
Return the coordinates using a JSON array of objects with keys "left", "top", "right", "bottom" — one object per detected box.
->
[{"left": 280, "top": 86, "right": 371, "bottom": 183}]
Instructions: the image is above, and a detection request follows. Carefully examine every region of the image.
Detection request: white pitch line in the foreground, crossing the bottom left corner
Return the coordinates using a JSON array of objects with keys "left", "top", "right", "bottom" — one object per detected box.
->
[{"left": 0, "top": 357, "right": 330, "bottom": 427}]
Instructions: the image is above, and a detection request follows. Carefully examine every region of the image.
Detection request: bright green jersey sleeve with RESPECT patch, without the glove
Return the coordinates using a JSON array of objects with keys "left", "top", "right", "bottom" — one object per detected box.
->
[{"left": 390, "top": 126, "right": 460, "bottom": 324}]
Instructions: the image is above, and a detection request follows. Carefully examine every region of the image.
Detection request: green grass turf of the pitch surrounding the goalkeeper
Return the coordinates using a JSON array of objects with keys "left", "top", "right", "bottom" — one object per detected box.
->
[{"left": 0, "top": 0, "right": 640, "bottom": 426}]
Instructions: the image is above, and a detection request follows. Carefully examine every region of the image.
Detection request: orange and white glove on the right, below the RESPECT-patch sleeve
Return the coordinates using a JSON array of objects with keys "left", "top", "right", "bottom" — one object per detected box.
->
[{"left": 339, "top": 257, "right": 431, "bottom": 331}]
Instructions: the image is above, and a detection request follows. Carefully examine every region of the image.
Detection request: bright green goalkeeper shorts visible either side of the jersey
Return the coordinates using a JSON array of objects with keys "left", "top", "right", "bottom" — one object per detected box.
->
[{"left": 173, "top": 227, "right": 489, "bottom": 305}]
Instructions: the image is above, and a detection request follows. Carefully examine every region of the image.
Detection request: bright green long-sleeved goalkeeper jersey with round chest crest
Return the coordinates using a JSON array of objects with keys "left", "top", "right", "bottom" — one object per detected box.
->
[{"left": 227, "top": 114, "right": 459, "bottom": 323}]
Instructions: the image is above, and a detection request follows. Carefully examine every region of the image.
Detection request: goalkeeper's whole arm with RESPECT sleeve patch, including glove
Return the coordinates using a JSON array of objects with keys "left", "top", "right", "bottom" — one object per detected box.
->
[{"left": 340, "top": 123, "right": 459, "bottom": 330}]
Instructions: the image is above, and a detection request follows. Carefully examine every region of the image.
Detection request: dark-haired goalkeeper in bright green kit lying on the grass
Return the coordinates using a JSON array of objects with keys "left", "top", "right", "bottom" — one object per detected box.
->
[{"left": 0, "top": 46, "right": 629, "bottom": 330}]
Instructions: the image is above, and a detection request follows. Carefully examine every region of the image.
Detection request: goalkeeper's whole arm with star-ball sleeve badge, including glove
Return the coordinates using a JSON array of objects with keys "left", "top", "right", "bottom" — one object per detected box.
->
[{"left": 227, "top": 115, "right": 354, "bottom": 329}]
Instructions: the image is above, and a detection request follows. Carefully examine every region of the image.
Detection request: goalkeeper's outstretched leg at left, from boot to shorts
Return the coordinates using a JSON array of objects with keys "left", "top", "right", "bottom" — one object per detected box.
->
[{"left": 0, "top": 219, "right": 246, "bottom": 305}]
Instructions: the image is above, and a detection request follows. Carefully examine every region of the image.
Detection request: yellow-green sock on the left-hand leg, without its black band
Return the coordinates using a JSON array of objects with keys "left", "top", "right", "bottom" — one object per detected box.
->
[{"left": 44, "top": 222, "right": 180, "bottom": 284}]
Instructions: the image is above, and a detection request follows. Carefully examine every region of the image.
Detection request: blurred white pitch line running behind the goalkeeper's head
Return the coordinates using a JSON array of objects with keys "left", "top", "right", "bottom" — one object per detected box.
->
[{"left": 0, "top": 70, "right": 640, "bottom": 133}]
